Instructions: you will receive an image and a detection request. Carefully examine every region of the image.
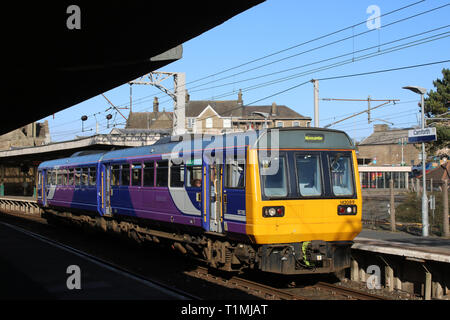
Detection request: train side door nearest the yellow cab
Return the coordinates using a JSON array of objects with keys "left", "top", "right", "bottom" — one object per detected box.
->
[{"left": 203, "top": 163, "right": 223, "bottom": 233}]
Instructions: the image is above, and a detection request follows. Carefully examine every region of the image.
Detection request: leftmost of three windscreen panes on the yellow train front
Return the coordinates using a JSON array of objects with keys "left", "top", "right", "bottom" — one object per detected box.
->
[{"left": 260, "top": 156, "right": 288, "bottom": 198}]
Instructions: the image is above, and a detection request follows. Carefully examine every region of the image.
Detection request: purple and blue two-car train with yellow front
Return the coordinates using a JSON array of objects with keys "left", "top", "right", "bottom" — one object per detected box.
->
[{"left": 37, "top": 127, "right": 362, "bottom": 275}]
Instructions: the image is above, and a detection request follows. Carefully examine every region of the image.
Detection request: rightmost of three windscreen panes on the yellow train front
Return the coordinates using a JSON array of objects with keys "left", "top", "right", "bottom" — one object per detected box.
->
[{"left": 330, "top": 153, "right": 353, "bottom": 196}]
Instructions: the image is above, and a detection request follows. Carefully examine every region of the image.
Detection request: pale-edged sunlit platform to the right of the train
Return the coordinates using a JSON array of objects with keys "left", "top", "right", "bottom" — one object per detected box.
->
[{"left": 352, "top": 229, "right": 450, "bottom": 263}]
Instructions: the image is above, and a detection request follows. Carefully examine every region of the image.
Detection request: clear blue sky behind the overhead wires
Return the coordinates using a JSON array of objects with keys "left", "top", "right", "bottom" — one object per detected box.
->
[{"left": 42, "top": 0, "right": 450, "bottom": 141}]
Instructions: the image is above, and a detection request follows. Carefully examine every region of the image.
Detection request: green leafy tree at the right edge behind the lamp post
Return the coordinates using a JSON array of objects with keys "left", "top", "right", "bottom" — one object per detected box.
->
[{"left": 424, "top": 68, "right": 450, "bottom": 153}]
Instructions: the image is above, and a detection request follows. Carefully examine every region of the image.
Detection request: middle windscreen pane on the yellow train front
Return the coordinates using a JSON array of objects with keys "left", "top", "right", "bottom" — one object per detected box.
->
[{"left": 295, "top": 154, "right": 322, "bottom": 197}]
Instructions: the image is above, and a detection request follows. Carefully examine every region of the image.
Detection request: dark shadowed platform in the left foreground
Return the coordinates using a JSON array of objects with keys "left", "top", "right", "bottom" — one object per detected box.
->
[{"left": 0, "top": 222, "right": 191, "bottom": 300}]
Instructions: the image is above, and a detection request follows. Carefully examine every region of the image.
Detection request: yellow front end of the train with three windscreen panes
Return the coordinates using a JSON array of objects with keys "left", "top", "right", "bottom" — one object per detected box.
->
[{"left": 246, "top": 128, "right": 362, "bottom": 274}]
